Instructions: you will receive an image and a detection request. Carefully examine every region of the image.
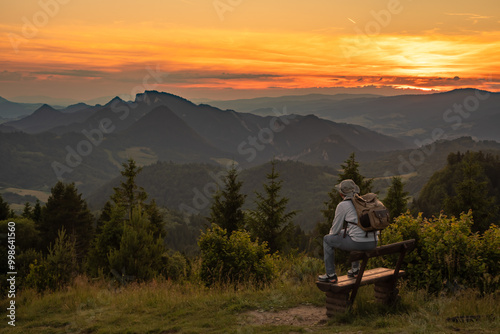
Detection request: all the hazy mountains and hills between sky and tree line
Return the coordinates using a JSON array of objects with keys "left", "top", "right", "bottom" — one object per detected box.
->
[{"left": 0, "top": 90, "right": 500, "bottom": 222}]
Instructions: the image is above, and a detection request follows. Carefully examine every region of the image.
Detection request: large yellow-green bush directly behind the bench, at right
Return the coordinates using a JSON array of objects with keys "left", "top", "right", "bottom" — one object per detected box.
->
[{"left": 377, "top": 212, "right": 500, "bottom": 292}]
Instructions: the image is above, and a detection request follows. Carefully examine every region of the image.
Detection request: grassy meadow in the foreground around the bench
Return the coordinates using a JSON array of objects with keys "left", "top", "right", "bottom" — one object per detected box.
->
[{"left": 0, "top": 275, "right": 500, "bottom": 334}]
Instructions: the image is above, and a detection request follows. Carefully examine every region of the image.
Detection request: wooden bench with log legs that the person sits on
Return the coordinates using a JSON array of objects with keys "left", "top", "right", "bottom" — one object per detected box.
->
[{"left": 316, "top": 239, "right": 415, "bottom": 317}]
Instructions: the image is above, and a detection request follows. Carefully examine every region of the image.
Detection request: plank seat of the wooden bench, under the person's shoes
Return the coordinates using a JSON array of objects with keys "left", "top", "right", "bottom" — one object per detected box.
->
[{"left": 316, "top": 268, "right": 405, "bottom": 292}]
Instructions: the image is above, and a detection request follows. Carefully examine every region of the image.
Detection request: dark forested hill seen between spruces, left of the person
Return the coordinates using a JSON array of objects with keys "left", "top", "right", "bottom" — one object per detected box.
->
[{"left": 87, "top": 161, "right": 337, "bottom": 231}]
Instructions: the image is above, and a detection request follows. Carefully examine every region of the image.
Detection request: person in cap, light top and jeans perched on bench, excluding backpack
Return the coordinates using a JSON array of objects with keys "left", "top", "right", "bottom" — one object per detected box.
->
[{"left": 318, "top": 179, "right": 378, "bottom": 283}]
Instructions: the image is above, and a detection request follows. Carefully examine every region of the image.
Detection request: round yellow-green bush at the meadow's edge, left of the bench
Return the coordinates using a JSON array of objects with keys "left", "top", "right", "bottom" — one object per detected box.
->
[{"left": 198, "top": 224, "right": 274, "bottom": 286}]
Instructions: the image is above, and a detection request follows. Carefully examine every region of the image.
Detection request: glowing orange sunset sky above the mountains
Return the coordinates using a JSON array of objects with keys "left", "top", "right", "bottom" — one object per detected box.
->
[{"left": 0, "top": 0, "right": 500, "bottom": 101}]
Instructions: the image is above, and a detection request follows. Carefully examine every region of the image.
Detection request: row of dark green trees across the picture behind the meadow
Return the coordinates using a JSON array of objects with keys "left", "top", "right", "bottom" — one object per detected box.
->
[{"left": 0, "top": 152, "right": 500, "bottom": 291}]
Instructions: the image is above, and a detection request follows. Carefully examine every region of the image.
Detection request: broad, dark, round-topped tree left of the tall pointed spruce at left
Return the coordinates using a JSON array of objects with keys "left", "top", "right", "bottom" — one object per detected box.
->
[{"left": 38, "top": 181, "right": 94, "bottom": 261}]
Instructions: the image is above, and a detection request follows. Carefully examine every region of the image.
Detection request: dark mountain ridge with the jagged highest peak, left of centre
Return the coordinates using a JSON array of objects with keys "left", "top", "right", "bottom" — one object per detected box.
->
[{"left": 3, "top": 91, "right": 405, "bottom": 165}]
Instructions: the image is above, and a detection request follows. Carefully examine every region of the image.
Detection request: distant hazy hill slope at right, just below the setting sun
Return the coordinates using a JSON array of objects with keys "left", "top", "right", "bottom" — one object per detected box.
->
[{"left": 205, "top": 89, "right": 500, "bottom": 142}]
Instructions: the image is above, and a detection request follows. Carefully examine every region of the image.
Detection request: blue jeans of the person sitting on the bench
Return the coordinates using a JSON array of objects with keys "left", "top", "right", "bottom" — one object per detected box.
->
[{"left": 323, "top": 230, "right": 377, "bottom": 275}]
